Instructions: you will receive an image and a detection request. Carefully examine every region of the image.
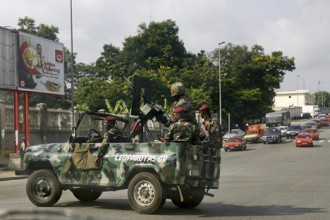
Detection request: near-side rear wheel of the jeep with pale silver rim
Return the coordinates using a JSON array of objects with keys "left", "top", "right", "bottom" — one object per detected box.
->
[{"left": 127, "top": 173, "right": 166, "bottom": 214}]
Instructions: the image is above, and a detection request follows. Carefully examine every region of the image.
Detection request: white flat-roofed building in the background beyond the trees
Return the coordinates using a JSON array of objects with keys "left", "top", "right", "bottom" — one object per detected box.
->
[{"left": 273, "top": 90, "right": 315, "bottom": 109}]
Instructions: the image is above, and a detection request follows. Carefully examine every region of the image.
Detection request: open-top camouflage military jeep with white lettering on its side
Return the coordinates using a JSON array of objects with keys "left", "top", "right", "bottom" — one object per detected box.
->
[{"left": 17, "top": 113, "right": 220, "bottom": 214}]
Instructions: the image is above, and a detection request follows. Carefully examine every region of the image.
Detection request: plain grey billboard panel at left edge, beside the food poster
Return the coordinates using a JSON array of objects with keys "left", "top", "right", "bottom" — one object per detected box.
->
[{"left": 0, "top": 27, "right": 18, "bottom": 89}]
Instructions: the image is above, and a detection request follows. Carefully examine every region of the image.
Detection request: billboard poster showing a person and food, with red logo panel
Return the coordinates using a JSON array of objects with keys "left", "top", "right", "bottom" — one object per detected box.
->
[{"left": 18, "top": 32, "right": 64, "bottom": 95}]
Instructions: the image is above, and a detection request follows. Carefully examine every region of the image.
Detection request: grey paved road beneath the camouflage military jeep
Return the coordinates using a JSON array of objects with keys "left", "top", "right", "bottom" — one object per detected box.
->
[{"left": 0, "top": 125, "right": 330, "bottom": 220}]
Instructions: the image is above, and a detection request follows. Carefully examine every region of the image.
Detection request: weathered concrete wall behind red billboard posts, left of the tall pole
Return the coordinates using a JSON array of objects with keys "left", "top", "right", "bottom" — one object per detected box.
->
[{"left": 0, "top": 100, "right": 71, "bottom": 156}]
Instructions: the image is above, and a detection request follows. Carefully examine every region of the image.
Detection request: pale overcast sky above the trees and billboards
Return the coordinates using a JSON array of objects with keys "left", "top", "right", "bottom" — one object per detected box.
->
[{"left": 0, "top": 0, "right": 330, "bottom": 93}]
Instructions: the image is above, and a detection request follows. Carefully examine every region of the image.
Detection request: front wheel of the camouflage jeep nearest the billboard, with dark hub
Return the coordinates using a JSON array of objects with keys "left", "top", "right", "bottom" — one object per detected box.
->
[{"left": 26, "top": 170, "right": 62, "bottom": 207}]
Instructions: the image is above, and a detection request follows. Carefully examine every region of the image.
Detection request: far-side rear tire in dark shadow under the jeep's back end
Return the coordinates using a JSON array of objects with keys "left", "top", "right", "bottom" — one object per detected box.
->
[{"left": 171, "top": 188, "right": 205, "bottom": 209}]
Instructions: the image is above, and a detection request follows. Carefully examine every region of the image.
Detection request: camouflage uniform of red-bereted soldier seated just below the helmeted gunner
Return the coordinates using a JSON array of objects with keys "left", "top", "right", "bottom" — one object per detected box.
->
[{"left": 164, "top": 119, "right": 195, "bottom": 143}]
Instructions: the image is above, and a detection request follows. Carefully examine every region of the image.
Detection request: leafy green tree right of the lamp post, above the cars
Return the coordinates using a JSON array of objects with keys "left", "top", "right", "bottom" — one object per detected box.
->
[{"left": 211, "top": 44, "right": 295, "bottom": 124}]
